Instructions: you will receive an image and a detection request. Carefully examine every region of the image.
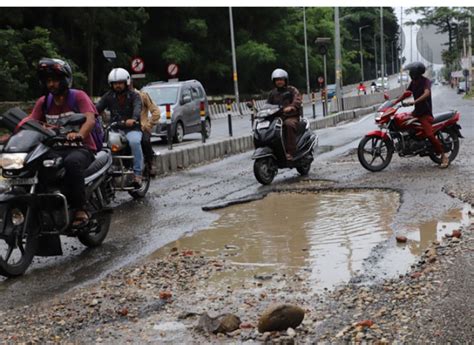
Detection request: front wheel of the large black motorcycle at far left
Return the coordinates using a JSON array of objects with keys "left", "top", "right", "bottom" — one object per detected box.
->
[{"left": 0, "top": 207, "right": 39, "bottom": 278}]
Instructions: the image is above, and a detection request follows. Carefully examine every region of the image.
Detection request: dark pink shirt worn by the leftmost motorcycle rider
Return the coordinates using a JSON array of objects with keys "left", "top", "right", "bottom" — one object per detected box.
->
[{"left": 31, "top": 90, "right": 97, "bottom": 152}]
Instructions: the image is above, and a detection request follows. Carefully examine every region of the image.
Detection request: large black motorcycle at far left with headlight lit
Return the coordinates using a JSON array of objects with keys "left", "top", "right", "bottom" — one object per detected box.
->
[{"left": 0, "top": 108, "right": 113, "bottom": 277}]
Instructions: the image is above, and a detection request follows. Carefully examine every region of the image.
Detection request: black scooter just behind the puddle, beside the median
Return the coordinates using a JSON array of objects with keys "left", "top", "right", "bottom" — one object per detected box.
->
[{"left": 252, "top": 104, "right": 318, "bottom": 185}]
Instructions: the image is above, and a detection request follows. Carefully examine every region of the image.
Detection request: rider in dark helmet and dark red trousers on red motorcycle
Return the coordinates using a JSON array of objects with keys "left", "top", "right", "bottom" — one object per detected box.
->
[{"left": 396, "top": 62, "right": 449, "bottom": 169}]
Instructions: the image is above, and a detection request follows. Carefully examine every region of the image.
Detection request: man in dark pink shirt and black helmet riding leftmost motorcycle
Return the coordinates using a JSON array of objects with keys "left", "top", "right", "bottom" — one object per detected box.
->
[{"left": 30, "top": 58, "right": 97, "bottom": 228}]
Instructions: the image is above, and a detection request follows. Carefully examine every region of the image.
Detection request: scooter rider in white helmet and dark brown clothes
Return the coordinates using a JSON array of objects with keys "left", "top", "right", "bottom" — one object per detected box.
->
[{"left": 267, "top": 68, "right": 303, "bottom": 161}]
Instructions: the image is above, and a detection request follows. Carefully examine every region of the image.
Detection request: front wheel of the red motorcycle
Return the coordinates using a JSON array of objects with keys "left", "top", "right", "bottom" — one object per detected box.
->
[{"left": 357, "top": 135, "right": 393, "bottom": 172}]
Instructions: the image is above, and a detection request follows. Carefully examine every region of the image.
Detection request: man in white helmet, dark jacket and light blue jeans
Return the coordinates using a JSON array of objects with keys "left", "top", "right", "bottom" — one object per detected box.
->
[{"left": 96, "top": 68, "right": 143, "bottom": 188}]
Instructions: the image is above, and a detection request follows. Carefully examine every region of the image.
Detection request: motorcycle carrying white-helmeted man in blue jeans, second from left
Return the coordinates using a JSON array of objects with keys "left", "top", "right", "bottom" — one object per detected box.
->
[{"left": 105, "top": 121, "right": 151, "bottom": 199}]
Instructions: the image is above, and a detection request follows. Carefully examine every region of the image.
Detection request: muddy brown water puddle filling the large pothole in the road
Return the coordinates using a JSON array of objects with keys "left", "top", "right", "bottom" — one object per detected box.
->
[{"left": 152, "top": 190, "right": 468, "bottom": 291}]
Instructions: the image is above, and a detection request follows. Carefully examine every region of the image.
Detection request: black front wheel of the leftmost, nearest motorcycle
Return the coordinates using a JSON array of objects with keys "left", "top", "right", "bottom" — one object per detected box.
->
[{"left": 0, "top": 207, "right": 39, "bottom": 277}]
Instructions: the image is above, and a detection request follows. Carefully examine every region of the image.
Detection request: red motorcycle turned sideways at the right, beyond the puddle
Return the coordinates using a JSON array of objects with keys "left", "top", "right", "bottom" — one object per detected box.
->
[{"left": 357, "top": 91, "right": 463, "bottom": 172}]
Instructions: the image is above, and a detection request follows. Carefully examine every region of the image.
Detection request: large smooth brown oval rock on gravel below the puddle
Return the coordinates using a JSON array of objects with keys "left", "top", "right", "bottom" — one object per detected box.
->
[{"left": 258, "top": 304, "right": 304, "bottom": 333}]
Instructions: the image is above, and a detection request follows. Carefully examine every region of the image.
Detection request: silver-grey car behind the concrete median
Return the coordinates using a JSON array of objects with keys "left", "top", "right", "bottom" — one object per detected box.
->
[{"left": 142, "top": 80, "right": 211, "bottom": 143}]
